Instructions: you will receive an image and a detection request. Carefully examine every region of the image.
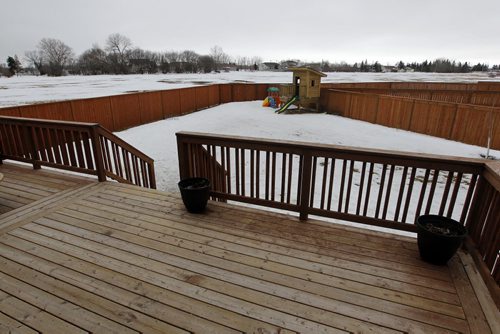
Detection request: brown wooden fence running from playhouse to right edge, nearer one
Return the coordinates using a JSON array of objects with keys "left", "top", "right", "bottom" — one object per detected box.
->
[{"left": 321, "top": 90, "right": 500, "bottom": 149}]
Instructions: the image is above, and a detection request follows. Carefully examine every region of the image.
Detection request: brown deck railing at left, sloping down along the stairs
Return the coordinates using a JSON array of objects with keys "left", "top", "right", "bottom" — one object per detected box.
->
[{"left": 0, "top": 117, "right": 156, "bottom": 188}]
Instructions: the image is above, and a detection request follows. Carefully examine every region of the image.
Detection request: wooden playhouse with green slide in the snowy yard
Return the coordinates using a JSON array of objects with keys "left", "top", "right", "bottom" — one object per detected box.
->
[{"left": 276, "top": 67, "right": 326, "bottom": 114}]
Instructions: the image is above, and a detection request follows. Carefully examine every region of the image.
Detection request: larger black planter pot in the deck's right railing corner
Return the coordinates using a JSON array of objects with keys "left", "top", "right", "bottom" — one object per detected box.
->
[{"left": 416, "top": 215, "right": 467, "bottom": 265}]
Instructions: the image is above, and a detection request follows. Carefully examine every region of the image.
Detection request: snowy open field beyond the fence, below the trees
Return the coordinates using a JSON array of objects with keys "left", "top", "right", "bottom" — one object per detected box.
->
[{"left": 0, "top": 71, "right": 498, "bottom": 107}]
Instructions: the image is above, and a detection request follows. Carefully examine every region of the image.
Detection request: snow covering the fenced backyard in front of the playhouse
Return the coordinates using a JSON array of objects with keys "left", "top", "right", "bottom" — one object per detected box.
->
[{"left": 116, "top": 101, "right": 500, "bottom": 235}]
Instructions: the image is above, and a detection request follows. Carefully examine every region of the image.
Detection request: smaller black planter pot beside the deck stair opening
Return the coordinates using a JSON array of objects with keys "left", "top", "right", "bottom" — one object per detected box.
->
[{"left": 178, "top": 177, "right": 210, "bottom": 213}]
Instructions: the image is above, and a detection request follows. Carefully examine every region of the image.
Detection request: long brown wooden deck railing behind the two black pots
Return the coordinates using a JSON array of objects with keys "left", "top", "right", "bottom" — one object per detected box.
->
[{"left": 177, "top": 132, "right": 500, "bottom": 290}]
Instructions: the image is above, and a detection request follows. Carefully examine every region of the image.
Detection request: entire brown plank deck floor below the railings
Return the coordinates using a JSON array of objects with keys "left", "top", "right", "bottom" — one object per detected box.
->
[{"left": 0, "top": 164, "right": 498, "bottom": 333}]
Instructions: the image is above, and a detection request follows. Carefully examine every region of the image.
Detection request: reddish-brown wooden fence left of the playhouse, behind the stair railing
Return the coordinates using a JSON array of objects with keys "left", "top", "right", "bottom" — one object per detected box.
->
[{"left": 0, "top": 84, "right": 268, "bottom": 132}]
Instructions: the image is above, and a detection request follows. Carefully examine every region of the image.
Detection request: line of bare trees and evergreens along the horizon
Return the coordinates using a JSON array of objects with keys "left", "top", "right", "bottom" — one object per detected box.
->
[{"left": 0, "top": 33, "right": 500, "bottom": 76}]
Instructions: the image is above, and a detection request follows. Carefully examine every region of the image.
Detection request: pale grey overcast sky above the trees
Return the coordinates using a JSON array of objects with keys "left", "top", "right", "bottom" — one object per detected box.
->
[{"left": 0, "top": 0, "right": 500, "bottom": 65}]
